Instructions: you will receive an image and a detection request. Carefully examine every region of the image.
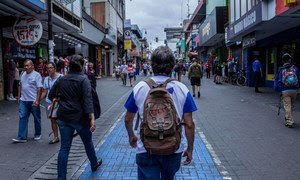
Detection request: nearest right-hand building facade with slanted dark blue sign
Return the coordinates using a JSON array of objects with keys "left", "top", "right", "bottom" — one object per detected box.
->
[{"left": 226, "top": 0, "right": 300, "bottom": 87}]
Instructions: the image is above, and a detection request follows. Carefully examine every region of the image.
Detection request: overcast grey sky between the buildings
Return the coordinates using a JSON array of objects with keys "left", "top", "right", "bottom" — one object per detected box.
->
[{"left": 126, "top": 0, "right": 198, "bottom": 48}]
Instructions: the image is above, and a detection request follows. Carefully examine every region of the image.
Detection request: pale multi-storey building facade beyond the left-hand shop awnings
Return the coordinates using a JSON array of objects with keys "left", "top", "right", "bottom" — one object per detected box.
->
[{"left": 84, "top": 0, "right": 125, "bottom": 76}]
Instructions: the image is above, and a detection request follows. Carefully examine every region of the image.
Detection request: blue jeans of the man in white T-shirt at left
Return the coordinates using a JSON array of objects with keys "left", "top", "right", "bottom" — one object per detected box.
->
[{"left": 18, "top": 101, "right": 42, "bottom": 139}]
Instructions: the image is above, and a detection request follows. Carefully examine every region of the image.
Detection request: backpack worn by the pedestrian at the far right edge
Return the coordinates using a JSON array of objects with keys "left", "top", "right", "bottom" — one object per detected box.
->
[{"left": 282, "top": 66, "right": 299, "bottom": 89}]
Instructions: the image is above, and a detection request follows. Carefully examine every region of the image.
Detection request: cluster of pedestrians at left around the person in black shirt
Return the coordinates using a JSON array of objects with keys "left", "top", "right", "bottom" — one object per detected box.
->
[{"left": 11, "top": 55, "right": 102, "bottom": 179}]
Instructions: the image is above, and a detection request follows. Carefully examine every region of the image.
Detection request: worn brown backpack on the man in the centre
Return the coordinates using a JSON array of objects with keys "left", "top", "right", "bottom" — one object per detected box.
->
[{"left": 135, "top": 78, "right": 182, "bottom": 155}]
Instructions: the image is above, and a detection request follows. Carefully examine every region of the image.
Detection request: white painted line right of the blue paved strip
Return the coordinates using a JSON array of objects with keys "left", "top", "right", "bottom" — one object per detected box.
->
[{"left": 197, "top": 128, "right": 232, "bottom": 180}]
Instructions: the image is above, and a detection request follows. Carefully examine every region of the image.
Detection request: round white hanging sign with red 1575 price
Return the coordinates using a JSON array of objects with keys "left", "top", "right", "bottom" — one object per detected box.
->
[{"left": 13, "top": 16, "right": 43, "bottom": 46}]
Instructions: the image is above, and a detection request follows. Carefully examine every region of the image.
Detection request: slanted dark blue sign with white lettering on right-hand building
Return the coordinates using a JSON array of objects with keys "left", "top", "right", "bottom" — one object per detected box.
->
[{"left": 226, "top": 3, "right": 262, "bottom": 42}]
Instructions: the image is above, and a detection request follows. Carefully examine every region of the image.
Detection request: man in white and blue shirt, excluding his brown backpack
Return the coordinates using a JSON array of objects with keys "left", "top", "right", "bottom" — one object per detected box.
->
[{"left": 125, "top": 46, "right": 197, "bottom": 180}]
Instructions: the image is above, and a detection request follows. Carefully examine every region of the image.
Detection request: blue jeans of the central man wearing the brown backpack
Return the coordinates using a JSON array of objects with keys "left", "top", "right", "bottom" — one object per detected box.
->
[{"left": 136, "top": 153, "right": 182, "bottom": 180}]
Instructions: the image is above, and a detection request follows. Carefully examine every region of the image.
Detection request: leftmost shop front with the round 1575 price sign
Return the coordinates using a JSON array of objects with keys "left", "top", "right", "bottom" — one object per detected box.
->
[{"left": 0, "top": 15, "right": 48, "bottom": 100}]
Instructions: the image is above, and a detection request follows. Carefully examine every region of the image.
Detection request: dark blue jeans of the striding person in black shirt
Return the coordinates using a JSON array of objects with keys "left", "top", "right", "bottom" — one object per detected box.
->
[{"left": 57, "top": 120, "right": 98, "bottom": 180}]
